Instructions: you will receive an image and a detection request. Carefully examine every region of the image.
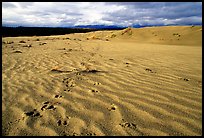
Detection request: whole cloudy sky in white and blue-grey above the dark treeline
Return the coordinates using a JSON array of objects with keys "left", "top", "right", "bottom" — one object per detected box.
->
[{"left": 2, "top": 2, "right": 202, "bottom": 27}]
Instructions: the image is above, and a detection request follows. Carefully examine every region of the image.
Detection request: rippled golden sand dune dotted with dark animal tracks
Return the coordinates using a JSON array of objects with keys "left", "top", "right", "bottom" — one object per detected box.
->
[{"left": 2, "top": 26, "right": 202, "bottom": 136}]
